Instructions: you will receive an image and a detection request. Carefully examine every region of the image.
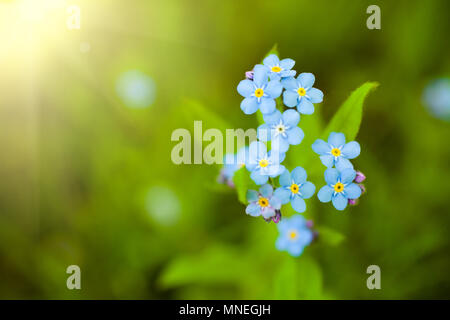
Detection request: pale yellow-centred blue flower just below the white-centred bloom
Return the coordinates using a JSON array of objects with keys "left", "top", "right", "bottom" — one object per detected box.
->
[{"left": 245, "top": 141, "right": 285, "bottom": 185}]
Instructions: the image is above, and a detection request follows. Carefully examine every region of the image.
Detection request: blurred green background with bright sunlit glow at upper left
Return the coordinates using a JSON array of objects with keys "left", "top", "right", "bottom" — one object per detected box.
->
[{"left": 0, "top": 0, "right": 450, "bottom": 299}]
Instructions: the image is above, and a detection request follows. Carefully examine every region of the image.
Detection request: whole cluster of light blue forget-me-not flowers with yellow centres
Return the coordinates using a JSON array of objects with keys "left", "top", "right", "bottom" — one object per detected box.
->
[{"left": 220, "top": 54, "right": 365, "bottom": 257}]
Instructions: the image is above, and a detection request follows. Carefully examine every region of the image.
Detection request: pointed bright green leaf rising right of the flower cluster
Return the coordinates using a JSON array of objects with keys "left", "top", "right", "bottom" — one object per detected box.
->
[{"left": 322, "top": 82, "right": 378, "bottom": 141}]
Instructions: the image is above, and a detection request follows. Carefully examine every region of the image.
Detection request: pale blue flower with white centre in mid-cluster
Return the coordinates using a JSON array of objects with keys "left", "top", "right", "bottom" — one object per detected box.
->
[{"left": 258, "top": 110, "right": 305, "bottom": 152}]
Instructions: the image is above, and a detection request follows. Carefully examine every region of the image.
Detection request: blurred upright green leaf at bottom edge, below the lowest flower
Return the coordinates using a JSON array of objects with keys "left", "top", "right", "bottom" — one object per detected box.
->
[{"left": 274, "top": 256, "right": 322, "bottom": 300}]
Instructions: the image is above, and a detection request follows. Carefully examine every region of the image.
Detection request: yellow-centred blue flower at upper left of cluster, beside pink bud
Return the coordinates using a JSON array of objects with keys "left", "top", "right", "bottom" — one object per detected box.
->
[{"left": 237, "top": 65, "right": 283, "bottom": 114}]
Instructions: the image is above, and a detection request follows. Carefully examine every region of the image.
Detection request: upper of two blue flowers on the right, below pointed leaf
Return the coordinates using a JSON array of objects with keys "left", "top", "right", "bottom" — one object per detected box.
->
[{"left": 312, "top": 132, "right": 361, "bottom": 171}]
